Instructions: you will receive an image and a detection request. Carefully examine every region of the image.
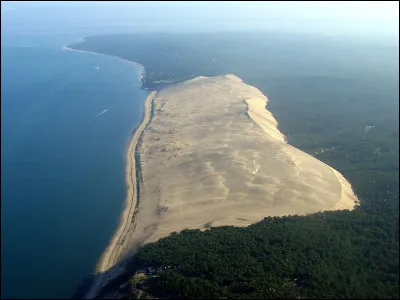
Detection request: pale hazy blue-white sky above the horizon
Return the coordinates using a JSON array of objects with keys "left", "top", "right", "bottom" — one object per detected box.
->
[{"left": 1, "top": 1, "right": 399, "bottom": 36}]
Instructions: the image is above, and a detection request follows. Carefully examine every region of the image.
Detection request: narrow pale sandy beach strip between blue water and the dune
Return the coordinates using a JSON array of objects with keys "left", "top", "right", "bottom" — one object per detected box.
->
[{"left": 86, "top": 91, "right": 157, "bottom": 299}]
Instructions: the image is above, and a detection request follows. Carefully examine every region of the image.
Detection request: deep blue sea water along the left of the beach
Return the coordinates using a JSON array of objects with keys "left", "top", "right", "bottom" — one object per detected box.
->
[{"left": 1, "top": 34, "right": 148, "bottom": 298}]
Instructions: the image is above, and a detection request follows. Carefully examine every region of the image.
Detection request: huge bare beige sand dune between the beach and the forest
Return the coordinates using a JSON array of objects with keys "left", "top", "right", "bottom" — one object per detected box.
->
[{"left": 123, "top": 75, "right": 358, "bottom": 249}]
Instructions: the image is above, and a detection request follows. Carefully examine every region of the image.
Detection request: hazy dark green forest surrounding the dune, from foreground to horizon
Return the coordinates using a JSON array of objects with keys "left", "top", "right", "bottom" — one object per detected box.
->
[{"left": 71, "top": 33, "right": 399, "bottom": 298}]
